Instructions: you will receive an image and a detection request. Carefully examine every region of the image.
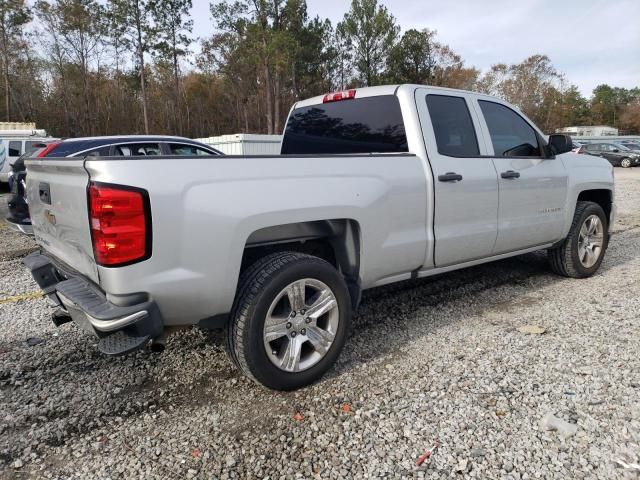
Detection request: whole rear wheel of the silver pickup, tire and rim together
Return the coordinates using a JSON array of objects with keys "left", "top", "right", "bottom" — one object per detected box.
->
[{"left": 227, "top": 252, "right": 351, "bottom": 390}]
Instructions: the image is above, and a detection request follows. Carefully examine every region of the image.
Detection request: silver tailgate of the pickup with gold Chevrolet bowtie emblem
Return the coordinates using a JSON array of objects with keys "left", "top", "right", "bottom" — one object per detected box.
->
[{"left": 26, "top": 158, "right": 98, "bottom": 283}]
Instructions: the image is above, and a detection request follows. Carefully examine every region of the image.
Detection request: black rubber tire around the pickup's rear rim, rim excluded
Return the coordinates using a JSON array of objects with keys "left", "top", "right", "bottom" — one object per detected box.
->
[{"left": 226, "top": 252, "right": 351, "bottom": 390}]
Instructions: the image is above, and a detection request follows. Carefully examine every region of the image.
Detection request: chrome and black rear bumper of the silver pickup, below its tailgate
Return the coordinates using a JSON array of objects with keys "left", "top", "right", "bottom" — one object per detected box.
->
[{"left": 23, "top": 253, "right": 163, "bottom": 355}]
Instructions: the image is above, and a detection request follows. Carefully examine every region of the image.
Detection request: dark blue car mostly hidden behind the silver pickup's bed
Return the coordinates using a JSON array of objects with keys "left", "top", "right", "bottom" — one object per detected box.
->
[{"left": 7, "top": 135, "right": 222, "bottom": 234}]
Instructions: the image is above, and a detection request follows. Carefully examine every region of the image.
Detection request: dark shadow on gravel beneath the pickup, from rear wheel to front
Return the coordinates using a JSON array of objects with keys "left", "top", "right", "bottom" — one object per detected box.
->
[{"left": 325, "top": 229, "right": 640, "bottom": 378}]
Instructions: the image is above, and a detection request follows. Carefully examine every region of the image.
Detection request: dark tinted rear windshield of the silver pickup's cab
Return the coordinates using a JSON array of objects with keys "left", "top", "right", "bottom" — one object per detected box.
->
[{"left": 281, "top": 95, "right": 408, "bottom": 155}]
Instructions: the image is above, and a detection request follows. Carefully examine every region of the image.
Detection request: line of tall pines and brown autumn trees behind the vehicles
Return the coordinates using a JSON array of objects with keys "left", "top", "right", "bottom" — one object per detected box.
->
[{"left": 0, "top": 0, "right": 640, "bottom": 137}]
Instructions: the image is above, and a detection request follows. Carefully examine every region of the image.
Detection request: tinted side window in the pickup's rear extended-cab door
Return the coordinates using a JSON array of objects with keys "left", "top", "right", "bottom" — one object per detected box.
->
[{"left": 427, "top": 95, "right": 480, "bottom": 157}]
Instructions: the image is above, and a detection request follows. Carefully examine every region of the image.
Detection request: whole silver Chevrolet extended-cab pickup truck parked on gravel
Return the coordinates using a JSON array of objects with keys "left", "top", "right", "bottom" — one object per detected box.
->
[{"left": 25, "top": 85, "right": 615, "bottom": 390}]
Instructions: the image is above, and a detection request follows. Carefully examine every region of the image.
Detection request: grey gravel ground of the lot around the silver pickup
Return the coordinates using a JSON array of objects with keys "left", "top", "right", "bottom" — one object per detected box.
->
[{"left": 0, "top": 168, "right": 640, "bottom": 479}]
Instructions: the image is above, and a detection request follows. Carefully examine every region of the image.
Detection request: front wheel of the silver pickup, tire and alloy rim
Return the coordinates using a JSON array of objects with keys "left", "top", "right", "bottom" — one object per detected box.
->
[{"left": 548, "top": 201, "right": 609, "bottom": 278}]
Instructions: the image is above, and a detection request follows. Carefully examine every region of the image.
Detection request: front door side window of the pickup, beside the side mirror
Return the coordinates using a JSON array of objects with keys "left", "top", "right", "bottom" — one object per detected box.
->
[{"left": 478, "top": 100, "right": 542, "bottom": 157}]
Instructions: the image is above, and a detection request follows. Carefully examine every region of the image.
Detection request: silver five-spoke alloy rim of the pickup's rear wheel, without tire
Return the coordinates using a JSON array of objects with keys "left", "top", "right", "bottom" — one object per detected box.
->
[{"left": 263, "top": 278, "right": 340, "bottom": 372}]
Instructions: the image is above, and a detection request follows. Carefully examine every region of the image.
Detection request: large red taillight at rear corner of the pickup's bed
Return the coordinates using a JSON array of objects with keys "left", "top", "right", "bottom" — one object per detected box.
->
[{"left": 89, "top": 183, "right": 151, "bottom": 267}]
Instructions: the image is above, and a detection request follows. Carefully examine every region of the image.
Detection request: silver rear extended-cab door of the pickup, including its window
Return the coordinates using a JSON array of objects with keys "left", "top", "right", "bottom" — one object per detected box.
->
[{"left": 416, "top": 88, "right": 498, "bottom": 267}]
